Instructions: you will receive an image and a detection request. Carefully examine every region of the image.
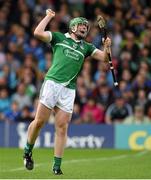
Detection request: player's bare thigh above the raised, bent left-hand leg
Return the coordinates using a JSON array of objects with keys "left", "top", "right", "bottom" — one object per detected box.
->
[{"left": 35, "top": 102, "right": 52, "bottom": 123}]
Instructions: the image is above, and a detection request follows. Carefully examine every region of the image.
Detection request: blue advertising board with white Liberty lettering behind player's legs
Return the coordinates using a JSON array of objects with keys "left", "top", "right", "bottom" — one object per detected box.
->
[{"left": 0, "top": 123, "right": 114, "bottom": 148}]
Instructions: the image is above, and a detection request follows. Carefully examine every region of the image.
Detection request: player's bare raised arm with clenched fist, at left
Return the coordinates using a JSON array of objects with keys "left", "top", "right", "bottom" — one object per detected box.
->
[{"left": 34, "top": 9, "right": 55, "bottom": 42}]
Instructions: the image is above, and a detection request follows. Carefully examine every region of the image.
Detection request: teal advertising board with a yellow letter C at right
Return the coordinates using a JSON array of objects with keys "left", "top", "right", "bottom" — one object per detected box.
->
[{"left": 115, "top": 125, "right": 151, "bottom": 150}]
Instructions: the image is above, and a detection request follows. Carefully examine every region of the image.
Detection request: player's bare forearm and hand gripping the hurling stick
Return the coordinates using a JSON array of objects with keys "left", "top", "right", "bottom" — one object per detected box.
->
[{"left": 92, "top": 37, "right": 111, "bottom": 62}]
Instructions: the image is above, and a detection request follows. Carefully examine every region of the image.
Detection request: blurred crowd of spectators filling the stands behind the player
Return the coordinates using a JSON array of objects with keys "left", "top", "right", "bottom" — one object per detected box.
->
[{"left": 0, "top": 0, "right": 151, "bottom": 124}]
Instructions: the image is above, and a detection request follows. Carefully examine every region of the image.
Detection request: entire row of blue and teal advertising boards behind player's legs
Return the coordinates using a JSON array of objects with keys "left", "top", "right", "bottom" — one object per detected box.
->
[{"left": 0, "top": 122, "right": 151, "bottom": 150}]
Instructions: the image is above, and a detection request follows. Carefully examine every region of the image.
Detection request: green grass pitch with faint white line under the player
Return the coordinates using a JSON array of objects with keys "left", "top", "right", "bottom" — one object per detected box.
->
[{"left": 0, "top": 148, "right": 151, "bottom": 179}]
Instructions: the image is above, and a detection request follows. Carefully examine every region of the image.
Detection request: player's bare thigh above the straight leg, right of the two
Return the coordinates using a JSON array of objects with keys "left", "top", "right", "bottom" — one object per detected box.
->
[{"left": 55, "top": 107, "right": 72, "bottom": 127}]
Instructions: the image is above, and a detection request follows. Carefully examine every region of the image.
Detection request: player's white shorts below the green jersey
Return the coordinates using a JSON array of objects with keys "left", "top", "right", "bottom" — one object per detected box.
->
[{"left": 40, "top": 80, "right": 75, "bottom": 113}]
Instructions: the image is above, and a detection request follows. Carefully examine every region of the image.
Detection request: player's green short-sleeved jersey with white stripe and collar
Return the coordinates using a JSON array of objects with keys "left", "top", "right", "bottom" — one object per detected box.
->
[{"left": 45, "top": 32, "right": 97, "bottom": 89}]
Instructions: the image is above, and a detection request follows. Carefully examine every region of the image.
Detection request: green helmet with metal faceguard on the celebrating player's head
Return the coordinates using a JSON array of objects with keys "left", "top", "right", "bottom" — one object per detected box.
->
[{"left": 69, "top": 17, "right": 90, "bottom": 39}]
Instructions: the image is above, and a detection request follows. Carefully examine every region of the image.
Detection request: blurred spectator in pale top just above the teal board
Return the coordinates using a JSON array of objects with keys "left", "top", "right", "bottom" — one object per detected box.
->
[{"left": 123, "top": 105, "right": 151, "bottom": 125}]
